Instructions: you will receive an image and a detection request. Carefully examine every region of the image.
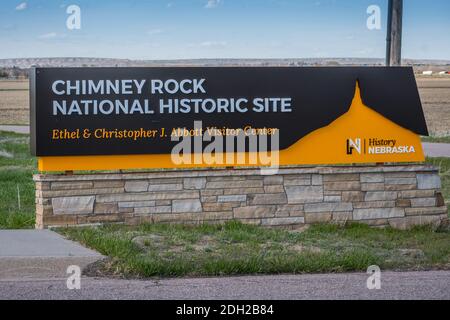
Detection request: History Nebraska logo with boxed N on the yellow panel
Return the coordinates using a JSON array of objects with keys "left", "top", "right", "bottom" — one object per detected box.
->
[{"left": 347, "top": 138, "right": 416, "bottom": 155}]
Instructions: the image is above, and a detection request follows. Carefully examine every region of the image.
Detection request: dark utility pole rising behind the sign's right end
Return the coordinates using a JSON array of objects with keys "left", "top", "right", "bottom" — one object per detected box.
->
[{"left": 386, "top": 0, "right": 403, "bottom": 66}]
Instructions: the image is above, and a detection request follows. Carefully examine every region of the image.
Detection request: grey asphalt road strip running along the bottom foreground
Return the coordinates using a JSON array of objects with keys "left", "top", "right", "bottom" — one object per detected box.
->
[{"left": 0, "top": 271, "right": 450, "bottom": 300}]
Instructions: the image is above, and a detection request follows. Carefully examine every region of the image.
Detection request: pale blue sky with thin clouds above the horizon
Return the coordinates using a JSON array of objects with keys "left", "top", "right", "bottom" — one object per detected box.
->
[{"left": 0, "top": 0, "right": 450, "bottom": 60}]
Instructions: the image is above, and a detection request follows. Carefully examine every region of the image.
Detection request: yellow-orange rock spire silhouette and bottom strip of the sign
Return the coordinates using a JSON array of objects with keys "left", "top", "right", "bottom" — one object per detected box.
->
[{"left": 38, "top": 85, "right": 425, "bottom": 171}]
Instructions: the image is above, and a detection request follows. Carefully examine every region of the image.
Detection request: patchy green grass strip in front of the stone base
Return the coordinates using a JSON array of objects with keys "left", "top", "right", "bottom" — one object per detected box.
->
[{"left": 58, "top": 221, "right": 450, "bottom": 278}]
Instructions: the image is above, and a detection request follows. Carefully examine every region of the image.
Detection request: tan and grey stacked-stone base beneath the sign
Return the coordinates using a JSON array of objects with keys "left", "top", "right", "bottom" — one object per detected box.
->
[{"left": 34, "top": 165, "right": 447, "bottom": 229}]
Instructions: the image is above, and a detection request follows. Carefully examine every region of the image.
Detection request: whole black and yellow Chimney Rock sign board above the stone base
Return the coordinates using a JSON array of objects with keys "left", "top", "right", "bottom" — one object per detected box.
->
[{"left": 30, "top": 67, "right": 428, "bottom": 171}]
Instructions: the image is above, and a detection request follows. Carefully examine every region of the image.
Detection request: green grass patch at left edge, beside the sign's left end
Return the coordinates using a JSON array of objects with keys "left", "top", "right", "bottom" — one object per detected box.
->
[{"left": 0, "top": 131, "right": 36, "bottom": 229}]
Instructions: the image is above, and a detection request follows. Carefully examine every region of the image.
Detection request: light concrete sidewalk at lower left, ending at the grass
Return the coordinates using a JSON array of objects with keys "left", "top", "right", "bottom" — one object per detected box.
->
[{"left": 0, "top": 230, "right": 103, "bottom": 280}]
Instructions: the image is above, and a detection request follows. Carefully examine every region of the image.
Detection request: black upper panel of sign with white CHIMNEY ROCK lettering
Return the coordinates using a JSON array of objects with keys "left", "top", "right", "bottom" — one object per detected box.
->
[{"left": 30, "top": 67, "right": 427, "bottom": 156}]
